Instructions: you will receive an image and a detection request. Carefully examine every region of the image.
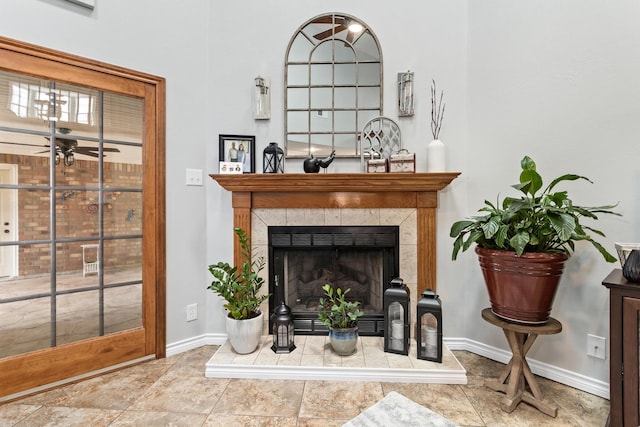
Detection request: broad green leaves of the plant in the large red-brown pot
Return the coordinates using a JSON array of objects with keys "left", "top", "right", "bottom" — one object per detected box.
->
[{"left": 450, "top": 156, "right": 620, "bottom": 262}]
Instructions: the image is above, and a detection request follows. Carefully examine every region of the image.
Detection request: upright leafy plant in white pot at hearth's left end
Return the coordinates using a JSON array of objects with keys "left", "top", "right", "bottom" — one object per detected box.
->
[{"left": 207, "top": 228, "right": 269, "bottom": 354}]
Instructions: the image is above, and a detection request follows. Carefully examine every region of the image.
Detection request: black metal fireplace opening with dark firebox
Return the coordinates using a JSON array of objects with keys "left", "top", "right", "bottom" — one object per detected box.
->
[{"left": 268, "top": 226, "right": 399, "bottom": 336}]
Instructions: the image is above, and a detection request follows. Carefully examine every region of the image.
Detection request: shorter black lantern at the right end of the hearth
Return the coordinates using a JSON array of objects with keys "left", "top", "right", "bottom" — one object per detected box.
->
[{"left": 416, "top": 289, "right": 442, "bottom": 363}]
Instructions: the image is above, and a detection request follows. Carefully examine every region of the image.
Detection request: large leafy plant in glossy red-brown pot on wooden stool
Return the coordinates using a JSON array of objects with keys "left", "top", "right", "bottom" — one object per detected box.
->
[{"left": 450, "top": 156, "right": 620, "bottom": 324}]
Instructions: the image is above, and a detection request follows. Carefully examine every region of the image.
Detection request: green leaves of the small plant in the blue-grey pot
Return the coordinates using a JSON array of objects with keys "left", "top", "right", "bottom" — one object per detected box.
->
[{"left": 318, "top": 284, "right": 364, "bottom": 329}]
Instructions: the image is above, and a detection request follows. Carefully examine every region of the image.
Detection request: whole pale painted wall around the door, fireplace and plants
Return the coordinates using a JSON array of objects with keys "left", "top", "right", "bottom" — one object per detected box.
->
[{"left": 5, "top": 0, "right": 640, "bottom": 392}]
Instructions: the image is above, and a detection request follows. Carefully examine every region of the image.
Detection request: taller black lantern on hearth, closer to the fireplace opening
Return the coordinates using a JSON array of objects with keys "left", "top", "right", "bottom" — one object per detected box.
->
[{"left": 383, "top": 277, "right": 409, "bottom": 355}]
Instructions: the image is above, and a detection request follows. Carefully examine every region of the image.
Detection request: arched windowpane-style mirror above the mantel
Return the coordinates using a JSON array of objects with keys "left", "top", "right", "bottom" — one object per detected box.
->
[{"left": 285, "top": 13, "right": 382, "bottom": 157}]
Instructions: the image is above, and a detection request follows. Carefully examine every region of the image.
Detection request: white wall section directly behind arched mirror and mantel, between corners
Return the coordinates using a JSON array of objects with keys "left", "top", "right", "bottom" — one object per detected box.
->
[{"left": 207, "top": 0, "right": 467, "bottom": 336}]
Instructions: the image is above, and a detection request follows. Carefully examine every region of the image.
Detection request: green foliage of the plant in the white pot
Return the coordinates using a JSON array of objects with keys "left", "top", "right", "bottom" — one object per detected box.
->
[{"left": 207, "top": 227, "right": 269, "bottom": 320}]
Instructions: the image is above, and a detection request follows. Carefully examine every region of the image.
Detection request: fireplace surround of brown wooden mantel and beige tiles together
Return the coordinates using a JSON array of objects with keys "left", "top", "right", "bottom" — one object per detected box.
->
[{"left": 208, "top": 172, "right": 459, "bottom": 384}]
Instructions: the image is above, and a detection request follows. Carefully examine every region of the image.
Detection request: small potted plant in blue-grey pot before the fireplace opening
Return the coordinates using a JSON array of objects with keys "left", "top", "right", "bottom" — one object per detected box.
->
[{"left": 318, "top": 284, "right": 364, "bottom": 356}]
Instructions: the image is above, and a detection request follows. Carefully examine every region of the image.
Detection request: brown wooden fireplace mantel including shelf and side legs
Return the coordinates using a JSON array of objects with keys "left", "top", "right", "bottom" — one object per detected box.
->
[{"left": 210, "top": 172, "right": 460, "bottom": 293}]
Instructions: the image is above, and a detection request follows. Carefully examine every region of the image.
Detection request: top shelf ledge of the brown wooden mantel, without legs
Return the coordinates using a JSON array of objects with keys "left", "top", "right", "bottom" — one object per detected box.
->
[{"left": 210, "top": 172, "right": 460, "bottom": 193}]
